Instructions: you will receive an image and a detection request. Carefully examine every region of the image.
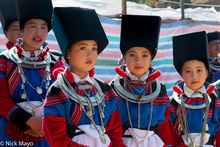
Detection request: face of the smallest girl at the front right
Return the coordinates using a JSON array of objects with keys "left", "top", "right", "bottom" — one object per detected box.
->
[{"left": 181, "top": 60, "right": 208, "bottom": 91}]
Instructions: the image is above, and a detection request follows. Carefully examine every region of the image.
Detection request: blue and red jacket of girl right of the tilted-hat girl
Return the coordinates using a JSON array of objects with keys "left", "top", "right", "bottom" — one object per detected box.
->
[{"left": 111, "top": 67, "right": 175, "bottom": 145}]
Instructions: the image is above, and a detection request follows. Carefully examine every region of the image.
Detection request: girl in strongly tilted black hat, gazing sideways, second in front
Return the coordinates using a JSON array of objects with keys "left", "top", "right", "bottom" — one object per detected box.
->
[{"left": 43, "top": 7, "right": 123, "bottom": 147}]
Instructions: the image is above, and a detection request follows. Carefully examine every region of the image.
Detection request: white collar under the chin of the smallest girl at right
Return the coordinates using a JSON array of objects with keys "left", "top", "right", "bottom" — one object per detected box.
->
[{"left": 183, "top": 83, "right": 206, "bottom": 98}]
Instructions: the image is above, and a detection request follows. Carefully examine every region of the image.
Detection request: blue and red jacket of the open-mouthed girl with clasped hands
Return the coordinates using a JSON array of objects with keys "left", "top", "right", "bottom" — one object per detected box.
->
[{"left": 0, "top": 47, "right": 64, "bottom": 146}]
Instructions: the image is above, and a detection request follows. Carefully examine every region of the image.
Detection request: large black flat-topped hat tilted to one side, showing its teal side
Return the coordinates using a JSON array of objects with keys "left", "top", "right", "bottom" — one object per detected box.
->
[{"left": 52, "top": 7, "right": 108, "bottom": 57}]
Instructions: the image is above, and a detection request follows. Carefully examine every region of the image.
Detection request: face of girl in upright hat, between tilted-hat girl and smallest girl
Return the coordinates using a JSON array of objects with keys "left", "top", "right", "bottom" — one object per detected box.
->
[{"left": 124, "top": 47, "right": 151, "bottom": 77}]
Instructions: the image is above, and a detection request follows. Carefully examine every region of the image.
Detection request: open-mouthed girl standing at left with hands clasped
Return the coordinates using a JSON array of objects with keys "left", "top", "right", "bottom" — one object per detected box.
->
[{"left": 0, "top": 0, "right": 64, "bottom": 147}]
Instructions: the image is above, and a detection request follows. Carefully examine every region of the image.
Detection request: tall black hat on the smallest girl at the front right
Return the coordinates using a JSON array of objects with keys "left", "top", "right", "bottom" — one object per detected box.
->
[{"left": 173, "top": 31, "right": 209, "bottom": 74}]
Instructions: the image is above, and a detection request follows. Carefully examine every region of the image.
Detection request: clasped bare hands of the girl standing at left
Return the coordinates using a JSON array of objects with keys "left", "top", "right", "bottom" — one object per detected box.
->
[{"left": 25, "top": 116, "right": 44, "bottom": 137}]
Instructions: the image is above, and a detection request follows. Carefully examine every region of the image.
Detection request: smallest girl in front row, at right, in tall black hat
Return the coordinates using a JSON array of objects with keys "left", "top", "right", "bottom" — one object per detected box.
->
[{"left": 170, "top": 31, "right": 220, "bottom": 147}]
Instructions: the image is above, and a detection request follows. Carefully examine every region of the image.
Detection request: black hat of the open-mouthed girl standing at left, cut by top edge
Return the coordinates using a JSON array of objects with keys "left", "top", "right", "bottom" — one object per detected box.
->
[{"left": 16, "top": 0, "right": 53, "bottom": 32}]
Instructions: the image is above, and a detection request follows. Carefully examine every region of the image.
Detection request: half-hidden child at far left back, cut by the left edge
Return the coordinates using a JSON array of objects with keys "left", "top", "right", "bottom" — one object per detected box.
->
[{"left": 0, "top": 0, "right": 21, "bottom": 49}]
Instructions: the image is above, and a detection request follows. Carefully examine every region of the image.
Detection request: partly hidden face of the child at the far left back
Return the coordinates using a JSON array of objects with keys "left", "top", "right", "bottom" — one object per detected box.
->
[{"left": 5, "top": 21, "right": 21, "bottom": 44}]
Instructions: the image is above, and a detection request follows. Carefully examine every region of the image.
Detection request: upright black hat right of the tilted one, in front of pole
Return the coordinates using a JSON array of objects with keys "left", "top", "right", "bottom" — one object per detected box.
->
[{"left": 120, "top": 15, "right": 161, "bottom": 59}]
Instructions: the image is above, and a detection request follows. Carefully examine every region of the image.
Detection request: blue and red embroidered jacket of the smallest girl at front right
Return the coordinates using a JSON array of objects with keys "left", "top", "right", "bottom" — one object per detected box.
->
[{"left": 170, "top": 81, "right": 220, "bottom": 145}]
